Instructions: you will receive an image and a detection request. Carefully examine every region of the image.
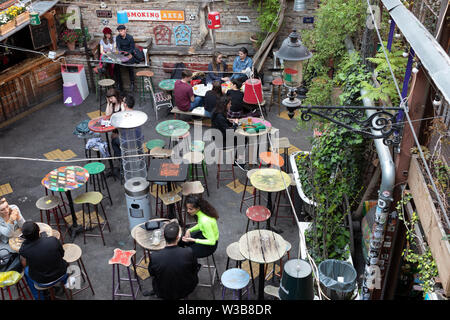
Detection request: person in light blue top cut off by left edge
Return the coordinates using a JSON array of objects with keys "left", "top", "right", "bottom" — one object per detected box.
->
[{"left": 0, "top": 198, "right": 25, "bottom": 257}]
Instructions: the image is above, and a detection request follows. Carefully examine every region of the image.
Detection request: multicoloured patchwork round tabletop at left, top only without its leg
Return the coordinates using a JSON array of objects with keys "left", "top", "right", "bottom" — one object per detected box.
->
[{"left": 41, "top": 166, "right": 89, "bottom": 192}]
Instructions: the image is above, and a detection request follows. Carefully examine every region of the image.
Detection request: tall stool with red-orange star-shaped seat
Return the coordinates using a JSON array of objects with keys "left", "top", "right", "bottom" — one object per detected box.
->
[{"left": 108, "top": 248, "right": 141, "bottom": 300}]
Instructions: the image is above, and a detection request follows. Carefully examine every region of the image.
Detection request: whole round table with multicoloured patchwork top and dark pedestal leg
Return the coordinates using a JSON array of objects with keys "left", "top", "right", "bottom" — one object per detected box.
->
[{"left": 41, "top": 166, "right": 89, "bottom": 240}]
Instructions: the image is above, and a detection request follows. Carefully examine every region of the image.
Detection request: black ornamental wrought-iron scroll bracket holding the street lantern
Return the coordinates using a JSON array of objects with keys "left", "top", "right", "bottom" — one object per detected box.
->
[{"left": 297, "top": 106, "right": 403, "bottom": 146}]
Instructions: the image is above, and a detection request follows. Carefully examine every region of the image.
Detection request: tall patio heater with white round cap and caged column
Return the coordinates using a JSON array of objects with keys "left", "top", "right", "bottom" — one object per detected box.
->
[{"left": 111, "top": 110, "right": 151, "bottom": 231}]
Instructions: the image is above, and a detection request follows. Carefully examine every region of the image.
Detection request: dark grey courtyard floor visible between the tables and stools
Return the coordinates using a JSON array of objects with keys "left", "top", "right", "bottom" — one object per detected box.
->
[{"left": 0, "top": 92, "right": 311, "bottom": 300}]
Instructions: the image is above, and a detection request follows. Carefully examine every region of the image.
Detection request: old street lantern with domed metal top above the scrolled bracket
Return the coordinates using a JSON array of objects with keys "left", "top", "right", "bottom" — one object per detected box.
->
[{"left": 277, "top": 30, "right": 312, "bottom": 119}]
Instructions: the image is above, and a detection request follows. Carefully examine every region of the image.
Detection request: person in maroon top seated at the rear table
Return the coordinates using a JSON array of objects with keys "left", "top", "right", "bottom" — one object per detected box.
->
[{"left": 173, "top": 70, "right": 203, "bottom": 111}]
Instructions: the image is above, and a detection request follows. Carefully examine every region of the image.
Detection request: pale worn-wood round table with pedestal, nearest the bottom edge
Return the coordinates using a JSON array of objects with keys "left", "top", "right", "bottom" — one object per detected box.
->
[{"left": 239, "top": 230, "right": 286, "bottom": 300}]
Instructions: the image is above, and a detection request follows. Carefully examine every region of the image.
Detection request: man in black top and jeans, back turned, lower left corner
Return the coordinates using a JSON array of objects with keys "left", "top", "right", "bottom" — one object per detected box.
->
[{"left": 19, "top": 221, "right": 68, "bottom": 300}]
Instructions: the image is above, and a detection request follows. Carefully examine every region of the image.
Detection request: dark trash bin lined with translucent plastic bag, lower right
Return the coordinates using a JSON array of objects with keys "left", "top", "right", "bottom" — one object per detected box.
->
[{"left": 318, "top": 259, "right": 356, "bottom": 300}]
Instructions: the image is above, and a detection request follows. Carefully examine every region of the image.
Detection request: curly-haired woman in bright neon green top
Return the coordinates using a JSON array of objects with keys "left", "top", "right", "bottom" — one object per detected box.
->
[{"left": 183, "top": 195, "right": 219, "bottom": 258}]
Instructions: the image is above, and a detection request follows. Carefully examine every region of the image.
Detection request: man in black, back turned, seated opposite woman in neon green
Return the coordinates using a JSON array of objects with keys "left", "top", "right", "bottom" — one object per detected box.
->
[{"left": 148, "top": 221, "right": 198, "bottom": 300}]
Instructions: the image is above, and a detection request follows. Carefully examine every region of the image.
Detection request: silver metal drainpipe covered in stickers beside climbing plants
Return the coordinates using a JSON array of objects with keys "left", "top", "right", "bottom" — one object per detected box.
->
[{"left": 345, "top": 38, "right": 395, "bottom": 300}]
